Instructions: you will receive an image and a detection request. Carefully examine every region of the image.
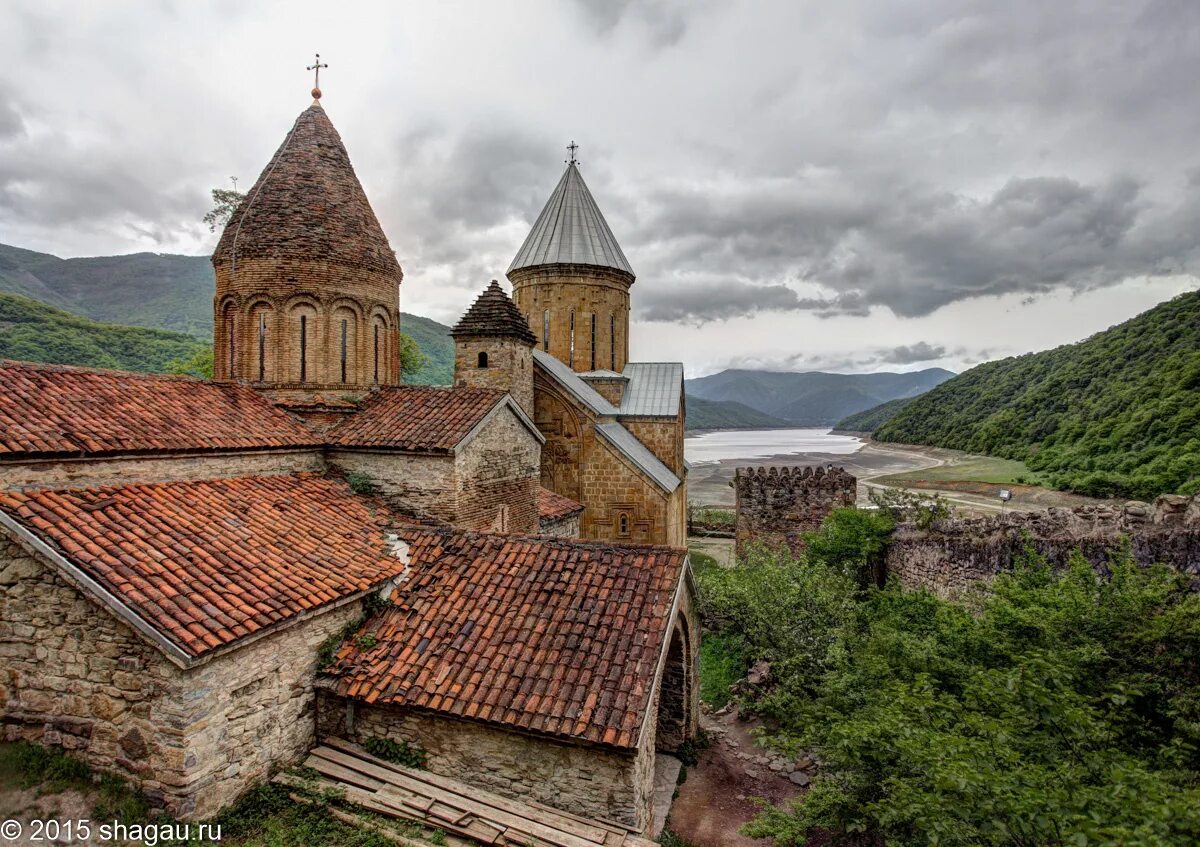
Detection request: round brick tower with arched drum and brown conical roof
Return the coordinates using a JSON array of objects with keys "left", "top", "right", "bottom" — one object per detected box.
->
[{"left": 212, "top": 103, "right": 403, "bottom": 391}]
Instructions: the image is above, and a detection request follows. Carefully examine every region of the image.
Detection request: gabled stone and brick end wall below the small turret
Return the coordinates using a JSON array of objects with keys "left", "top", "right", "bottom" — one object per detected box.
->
[{"left": 455, "top": 407, "right": 541, "bottom": 533}]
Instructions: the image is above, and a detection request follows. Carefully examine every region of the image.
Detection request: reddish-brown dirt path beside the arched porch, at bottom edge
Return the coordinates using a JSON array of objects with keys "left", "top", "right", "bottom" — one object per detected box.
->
[{"left": 667, "top": 709, "right": 809, "bottom": 847}]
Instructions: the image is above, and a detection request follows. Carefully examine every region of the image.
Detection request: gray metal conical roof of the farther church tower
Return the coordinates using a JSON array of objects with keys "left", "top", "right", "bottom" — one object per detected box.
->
[{"left": 509, "top": 162, "right": 634, "bottom": 276}]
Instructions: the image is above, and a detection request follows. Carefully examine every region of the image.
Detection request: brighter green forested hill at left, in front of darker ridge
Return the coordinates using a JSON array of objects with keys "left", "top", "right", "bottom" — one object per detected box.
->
[{"left": 0, "top": 293, "right": 209, "bottom": 372}]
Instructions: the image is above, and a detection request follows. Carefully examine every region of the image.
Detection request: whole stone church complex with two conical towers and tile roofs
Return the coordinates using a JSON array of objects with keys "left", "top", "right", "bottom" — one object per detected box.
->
[{"left": 0, "top": 91, "right": 700, "bottom": 831}]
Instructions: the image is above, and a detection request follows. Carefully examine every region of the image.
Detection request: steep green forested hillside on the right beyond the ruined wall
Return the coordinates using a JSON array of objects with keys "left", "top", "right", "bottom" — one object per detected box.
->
[{"left": 875, "top": 292, "right": 1200, "bottom": 499}]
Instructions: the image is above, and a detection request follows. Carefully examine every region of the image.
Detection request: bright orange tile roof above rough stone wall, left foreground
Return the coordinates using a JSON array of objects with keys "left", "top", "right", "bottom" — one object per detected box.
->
[{"left": 0, "top": 474, "right": 403, "bottom": 657}]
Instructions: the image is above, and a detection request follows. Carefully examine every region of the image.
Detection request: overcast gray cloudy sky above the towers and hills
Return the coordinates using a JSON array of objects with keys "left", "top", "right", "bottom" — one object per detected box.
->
[{"left": 0, "top": 0, "right": 1200, "bottom": 376}]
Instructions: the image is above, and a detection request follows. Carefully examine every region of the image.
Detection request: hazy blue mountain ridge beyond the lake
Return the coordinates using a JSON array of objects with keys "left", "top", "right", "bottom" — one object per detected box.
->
[{"left": 684, "top": 367, "right": 954, "bottom": 426}]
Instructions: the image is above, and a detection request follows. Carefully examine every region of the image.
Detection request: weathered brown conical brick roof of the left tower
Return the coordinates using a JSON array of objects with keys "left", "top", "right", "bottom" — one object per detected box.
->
[{"left": 212, "top": 103, "right": 401, "bottom": 276}]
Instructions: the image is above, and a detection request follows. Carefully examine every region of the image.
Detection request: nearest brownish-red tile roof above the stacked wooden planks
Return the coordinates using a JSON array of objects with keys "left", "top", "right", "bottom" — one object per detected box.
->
[{"left": 331, "top": 528, "right": 685, "bottom": 750}]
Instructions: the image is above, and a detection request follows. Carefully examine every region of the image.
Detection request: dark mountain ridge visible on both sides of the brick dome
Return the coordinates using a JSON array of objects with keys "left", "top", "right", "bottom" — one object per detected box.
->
[{"left": 0, "top": 244, "right": 454, "bottom": 385}]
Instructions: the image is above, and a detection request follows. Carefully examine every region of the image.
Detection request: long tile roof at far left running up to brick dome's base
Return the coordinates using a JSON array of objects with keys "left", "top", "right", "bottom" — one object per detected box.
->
[{"left": 0, "top": 361, "right": 322, "bottom": 457}]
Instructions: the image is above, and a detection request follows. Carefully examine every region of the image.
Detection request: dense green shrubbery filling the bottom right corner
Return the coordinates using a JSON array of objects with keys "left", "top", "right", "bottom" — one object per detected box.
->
[{"left": 743, "top": 544, "right": 1200, "bottom": 847}]
